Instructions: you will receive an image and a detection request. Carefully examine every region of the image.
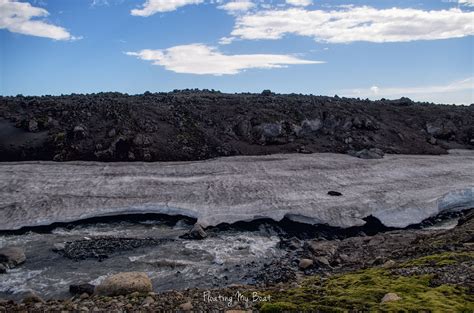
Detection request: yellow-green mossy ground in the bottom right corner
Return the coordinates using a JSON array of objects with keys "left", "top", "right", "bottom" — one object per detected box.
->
[{"left": 260, "top": 252, "right": 474, "bottom": 312}]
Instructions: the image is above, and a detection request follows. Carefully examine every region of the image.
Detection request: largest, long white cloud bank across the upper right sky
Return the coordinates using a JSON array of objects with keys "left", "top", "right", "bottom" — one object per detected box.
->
[{"left": 231, "top": 6, "right": 474, "bottom": 43}]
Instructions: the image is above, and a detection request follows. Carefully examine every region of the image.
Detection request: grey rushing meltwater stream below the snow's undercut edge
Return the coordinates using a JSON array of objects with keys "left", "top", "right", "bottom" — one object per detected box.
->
[{"left": 0, "top": 220, "right": 284, "bottom": 299}]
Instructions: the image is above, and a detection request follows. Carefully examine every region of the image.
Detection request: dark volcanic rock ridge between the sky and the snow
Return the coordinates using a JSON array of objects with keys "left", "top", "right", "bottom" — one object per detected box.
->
[{"left": 0, "top": 90, "right": 474, "bottom": 161}]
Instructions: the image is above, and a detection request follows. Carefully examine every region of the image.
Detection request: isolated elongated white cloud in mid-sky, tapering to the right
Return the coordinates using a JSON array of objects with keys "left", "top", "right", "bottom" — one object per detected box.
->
[{"left": 126, "top": 43, "right": 324, "bottom": 75}]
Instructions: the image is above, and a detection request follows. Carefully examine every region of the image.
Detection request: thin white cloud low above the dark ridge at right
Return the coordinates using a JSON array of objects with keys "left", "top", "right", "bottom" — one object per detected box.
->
[{"left": 338, "top": 77, "right": 474, "bottom": 104}]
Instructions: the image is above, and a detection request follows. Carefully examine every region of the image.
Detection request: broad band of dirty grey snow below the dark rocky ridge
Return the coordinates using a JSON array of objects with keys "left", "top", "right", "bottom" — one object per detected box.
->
[{"left": 0, "top": 151, "right": 474, "bottom": 230}]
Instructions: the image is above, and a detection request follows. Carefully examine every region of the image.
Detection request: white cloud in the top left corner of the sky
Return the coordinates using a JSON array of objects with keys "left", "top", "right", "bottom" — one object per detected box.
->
[{"left": 0, "top": 0, "right": 75, "bottom": 40}]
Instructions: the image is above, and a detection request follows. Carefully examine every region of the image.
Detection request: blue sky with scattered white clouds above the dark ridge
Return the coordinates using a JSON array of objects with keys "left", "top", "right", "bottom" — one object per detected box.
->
[{"left": 0, "top": 0, "right": 474, "bottom": 104}]
